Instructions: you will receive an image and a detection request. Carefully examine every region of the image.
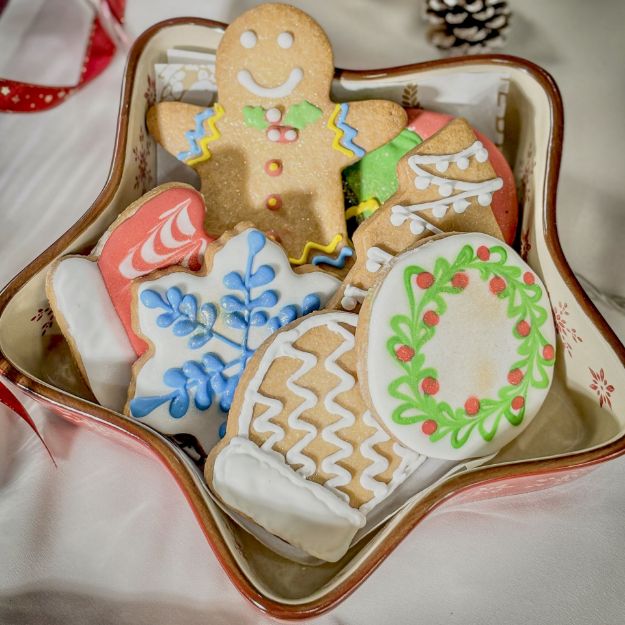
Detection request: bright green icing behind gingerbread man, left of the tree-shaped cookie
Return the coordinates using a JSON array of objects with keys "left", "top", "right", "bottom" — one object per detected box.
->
[{"left": 343, "top": 128, "right": 422, "bottom": 210}]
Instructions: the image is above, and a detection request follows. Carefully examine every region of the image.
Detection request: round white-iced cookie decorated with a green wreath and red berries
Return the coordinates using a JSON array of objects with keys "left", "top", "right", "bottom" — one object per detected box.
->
[{"left": 357, "top": 233, "right": 555, "bottom": 460}]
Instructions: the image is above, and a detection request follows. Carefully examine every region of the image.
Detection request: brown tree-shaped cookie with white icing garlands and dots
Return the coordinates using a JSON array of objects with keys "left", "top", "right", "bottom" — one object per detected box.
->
[{"left": 330, "top": 118, "right": 503, "bottom": 311}]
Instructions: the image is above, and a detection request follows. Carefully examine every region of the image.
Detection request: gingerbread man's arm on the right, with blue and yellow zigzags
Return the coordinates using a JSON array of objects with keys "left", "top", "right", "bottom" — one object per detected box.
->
[{"left": 336, "top": 100, "right": 407, "bottom": 166}]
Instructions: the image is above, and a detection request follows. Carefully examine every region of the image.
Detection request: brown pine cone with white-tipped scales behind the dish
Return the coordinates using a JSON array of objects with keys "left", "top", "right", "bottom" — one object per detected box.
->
[{"left": 424, "top": 0, "right": 511, "bottom": 54}]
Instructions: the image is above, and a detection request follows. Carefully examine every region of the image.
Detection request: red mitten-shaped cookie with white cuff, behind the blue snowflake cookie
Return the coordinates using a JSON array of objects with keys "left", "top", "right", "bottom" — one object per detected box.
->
[{"left": 46, "top": 184, "right": 211, "bottom": 412}]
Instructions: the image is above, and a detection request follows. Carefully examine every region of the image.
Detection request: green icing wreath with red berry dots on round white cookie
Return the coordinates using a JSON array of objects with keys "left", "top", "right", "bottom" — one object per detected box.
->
[{"left": 387, "top": 240, "right": 554, "bottom": 449}]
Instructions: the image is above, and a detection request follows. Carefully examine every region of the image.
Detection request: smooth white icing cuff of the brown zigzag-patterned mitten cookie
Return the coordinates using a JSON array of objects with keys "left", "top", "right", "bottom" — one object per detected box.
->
[{"left": 213, "top": 437, "right": 365, "bottom": 562}]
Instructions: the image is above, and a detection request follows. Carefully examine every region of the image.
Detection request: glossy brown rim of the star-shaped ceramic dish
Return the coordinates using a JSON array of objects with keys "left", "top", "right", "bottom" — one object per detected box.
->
[{"left": 0, "top": 17, "right": 625, "bottom": 620}]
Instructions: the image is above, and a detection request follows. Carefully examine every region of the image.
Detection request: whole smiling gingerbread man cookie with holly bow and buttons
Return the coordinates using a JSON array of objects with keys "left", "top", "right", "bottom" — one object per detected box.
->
[{"left": 147, "top": 4, "right": 406, "bottom": 267}]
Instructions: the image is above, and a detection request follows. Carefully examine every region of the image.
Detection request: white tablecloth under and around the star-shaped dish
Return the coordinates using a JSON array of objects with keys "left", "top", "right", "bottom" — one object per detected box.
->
[{"left": 0, "top": 0, "right": 625, "bottom": 625}]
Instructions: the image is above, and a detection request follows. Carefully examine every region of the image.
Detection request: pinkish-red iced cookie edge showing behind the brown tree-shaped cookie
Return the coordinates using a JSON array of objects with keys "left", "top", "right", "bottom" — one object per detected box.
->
[{"left": 406, "top": 108, "right": 519, "bottom": 243}]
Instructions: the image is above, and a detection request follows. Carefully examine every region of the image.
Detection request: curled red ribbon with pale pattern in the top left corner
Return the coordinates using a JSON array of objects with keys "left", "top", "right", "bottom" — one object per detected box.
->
[{"left": 0, "top": 0, "right": 125, "bottom": 113}]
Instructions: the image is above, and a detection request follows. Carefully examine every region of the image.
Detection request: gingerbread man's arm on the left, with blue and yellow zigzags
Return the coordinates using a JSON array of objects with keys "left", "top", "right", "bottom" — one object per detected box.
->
[{"left": 146, "top": 102, "right": 221, "bottom": 165}]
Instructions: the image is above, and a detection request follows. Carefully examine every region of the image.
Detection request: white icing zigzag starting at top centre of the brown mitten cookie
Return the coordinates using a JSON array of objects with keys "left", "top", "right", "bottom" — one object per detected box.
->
[{"left": 321, "top": 322, "right": 356, "bottom": 500}]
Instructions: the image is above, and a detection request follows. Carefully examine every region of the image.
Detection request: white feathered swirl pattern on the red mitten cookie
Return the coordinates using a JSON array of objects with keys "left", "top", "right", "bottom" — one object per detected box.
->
[{"left": 119, "top": 198, "right": 200, "bottom": 280}]
